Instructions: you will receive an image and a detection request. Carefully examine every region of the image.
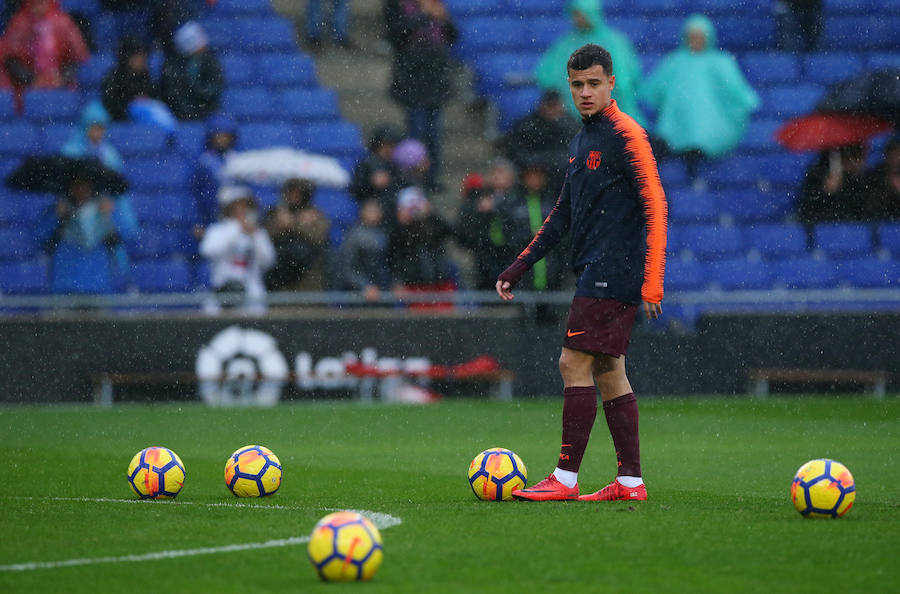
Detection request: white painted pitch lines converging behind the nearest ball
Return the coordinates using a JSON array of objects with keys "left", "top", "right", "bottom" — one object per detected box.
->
[{"left": 0, "top": 497, "right": 403, "bottom": 571}]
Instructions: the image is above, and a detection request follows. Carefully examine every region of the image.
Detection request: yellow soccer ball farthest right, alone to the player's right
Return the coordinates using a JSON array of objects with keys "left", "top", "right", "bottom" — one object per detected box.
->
[{"left": 791, "top": 458, "right": 856, "bottom": 518}]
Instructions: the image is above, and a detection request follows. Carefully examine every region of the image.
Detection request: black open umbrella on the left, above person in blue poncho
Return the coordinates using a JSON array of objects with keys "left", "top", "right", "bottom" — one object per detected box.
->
[{"left": 6, "top": 155, "right": 128, "bottom": 195}]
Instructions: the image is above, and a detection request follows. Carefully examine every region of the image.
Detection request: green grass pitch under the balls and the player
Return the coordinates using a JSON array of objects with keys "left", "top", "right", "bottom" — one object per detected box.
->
[{"left": 0, "top": 396, "right": 900, "bottom": 594}]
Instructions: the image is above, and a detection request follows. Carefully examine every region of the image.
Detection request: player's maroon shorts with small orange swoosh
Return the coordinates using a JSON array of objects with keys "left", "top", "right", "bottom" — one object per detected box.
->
[{"left": 563, "top": 297, "right": 638, "bottom": 357}]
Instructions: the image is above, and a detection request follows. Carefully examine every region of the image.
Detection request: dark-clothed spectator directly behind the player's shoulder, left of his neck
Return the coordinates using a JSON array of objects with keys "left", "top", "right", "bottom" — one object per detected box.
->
[{"left": 502, "top": 90, "right": 579, "bottom": 190}]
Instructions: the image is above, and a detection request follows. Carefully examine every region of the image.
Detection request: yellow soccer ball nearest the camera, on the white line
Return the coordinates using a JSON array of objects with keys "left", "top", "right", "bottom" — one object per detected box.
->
[{"left": 307, "top": 511, "right": 384, "bottom": 582}]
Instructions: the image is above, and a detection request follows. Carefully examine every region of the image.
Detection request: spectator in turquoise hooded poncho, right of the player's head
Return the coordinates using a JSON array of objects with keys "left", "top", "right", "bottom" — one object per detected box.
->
[{"left": 640, "top": 14, "right": 759, "bottom": 188}]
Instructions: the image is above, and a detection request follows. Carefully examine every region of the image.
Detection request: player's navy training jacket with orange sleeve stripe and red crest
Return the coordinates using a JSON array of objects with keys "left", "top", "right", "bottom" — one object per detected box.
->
[{"left": 510, "top": 100, "right": 668, "bottom": 303}]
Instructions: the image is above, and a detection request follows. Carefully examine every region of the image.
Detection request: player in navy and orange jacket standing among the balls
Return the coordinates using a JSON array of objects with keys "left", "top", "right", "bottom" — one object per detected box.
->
[{"left": 496, "top": 44, "right": 667, "bottom": 501}]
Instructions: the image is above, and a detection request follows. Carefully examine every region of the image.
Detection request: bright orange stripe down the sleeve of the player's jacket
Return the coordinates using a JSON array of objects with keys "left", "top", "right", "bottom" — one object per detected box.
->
[{"left": 609, "top": 109, "right": 668, "bottom": 303}]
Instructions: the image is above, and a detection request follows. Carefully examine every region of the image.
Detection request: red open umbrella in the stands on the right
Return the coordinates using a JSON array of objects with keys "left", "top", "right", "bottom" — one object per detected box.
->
[{"left": 775, "top": 113, "right": 893, "bottom": 151}]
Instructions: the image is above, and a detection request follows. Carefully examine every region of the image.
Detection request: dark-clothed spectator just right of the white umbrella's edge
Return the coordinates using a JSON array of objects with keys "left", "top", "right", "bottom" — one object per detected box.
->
[{"left": 350, "top": 126, "right": 403, "bottom": 209}]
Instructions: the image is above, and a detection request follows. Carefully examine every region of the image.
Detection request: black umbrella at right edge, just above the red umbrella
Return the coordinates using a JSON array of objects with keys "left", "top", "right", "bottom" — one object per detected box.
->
[{"left": 816, "top": 68, "right": 900, "bottom": 126}]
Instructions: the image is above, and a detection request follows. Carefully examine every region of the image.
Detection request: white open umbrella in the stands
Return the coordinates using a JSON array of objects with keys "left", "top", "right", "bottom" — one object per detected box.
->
[{"left": 225, "top": 147, "right": 350, "bottom": 188}]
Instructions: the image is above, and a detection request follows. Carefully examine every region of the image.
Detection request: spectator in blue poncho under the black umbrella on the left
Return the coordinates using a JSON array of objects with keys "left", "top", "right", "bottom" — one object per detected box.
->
[{"left": 36, "top": 166, "right": 138, "bottom": 293}]
